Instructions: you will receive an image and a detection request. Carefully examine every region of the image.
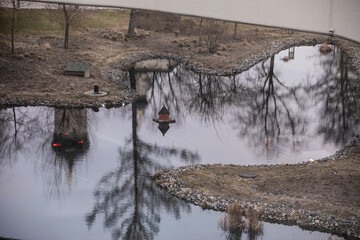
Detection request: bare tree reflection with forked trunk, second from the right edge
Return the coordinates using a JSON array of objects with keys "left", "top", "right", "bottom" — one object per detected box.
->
[{"left": 234, "top": 56, "right": 307, "bottom": 157}]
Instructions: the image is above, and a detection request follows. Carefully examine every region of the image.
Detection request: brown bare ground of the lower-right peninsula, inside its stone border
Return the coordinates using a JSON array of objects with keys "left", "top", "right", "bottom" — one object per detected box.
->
[{"left": 182, "top": 140, "right": 360, "bottom": 219}]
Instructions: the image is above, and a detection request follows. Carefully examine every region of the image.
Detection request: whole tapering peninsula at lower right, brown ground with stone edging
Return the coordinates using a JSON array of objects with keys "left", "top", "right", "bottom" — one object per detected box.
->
[{"left": 155, "top": 137, "right": 360, "bottom": 239}]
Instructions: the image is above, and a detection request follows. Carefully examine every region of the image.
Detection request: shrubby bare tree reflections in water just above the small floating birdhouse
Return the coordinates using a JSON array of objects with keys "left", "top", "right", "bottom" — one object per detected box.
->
[{"left": 143, "top": 66, "right": 242, "bottom": 124}]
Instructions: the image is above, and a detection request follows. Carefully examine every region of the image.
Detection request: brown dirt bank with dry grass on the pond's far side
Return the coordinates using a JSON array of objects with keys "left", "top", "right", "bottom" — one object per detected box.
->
[{"left": 0, "top": 22, "right": 305, "bottom": 105}]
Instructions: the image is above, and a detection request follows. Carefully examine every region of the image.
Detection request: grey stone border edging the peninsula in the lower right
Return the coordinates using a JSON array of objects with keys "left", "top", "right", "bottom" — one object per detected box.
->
[{"left": 156, "top": 138, "right": 360, "bottom": 239}]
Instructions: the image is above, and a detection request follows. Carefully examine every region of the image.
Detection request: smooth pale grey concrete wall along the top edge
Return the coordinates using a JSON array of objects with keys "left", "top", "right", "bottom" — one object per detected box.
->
[{"left": 31, "top": 0, "right": 360, "bottom": 42}]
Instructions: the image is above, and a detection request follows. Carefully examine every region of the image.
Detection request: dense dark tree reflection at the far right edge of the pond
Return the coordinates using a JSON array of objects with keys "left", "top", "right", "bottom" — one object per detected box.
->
[{"left": 308, "top": 47, "right": 360, "bottom": 145}]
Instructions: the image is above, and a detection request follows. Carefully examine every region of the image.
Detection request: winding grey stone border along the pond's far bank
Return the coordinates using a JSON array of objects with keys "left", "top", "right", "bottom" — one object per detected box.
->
[{"left": 0, "top": 35, "right": 360, "bottom": 108}]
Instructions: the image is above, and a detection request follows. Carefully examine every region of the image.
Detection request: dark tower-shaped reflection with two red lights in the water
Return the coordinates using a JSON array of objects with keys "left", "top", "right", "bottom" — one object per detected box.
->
[{"left": 51, "top": 109, "right": 90, "bottom": 191}]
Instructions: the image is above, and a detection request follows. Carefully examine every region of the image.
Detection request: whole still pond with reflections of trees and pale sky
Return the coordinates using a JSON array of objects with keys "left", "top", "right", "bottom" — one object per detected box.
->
[{"left": 0, "top": 46, "right": 360, "bottom": 240}]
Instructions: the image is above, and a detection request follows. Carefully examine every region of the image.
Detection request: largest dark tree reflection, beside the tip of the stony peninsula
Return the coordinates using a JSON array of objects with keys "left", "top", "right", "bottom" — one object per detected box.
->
[{"left": 86, "top": 104, "right": 199, "bottom": 239}]
